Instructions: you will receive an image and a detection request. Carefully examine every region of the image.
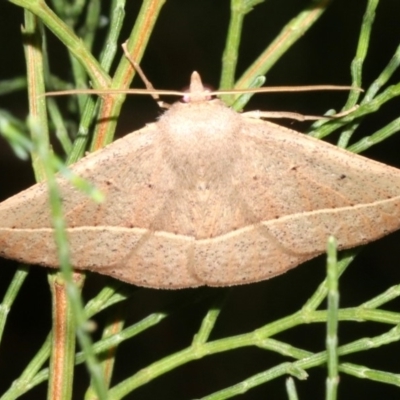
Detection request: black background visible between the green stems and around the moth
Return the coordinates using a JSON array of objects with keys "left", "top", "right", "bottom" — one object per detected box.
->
[{"left": 0, "top": 0, "right": 400, "bottom": 400}]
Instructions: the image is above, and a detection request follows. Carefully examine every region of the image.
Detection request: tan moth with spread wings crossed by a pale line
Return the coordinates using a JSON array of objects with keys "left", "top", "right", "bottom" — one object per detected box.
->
[{"left": 0, "top": 73, "right": 400, "bottom": 289}]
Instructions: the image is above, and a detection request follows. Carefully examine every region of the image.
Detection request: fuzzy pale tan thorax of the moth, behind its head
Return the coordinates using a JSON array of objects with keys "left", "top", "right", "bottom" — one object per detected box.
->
[{"left": 160, "top": 100, "right": 240, "bottom": 181}]
